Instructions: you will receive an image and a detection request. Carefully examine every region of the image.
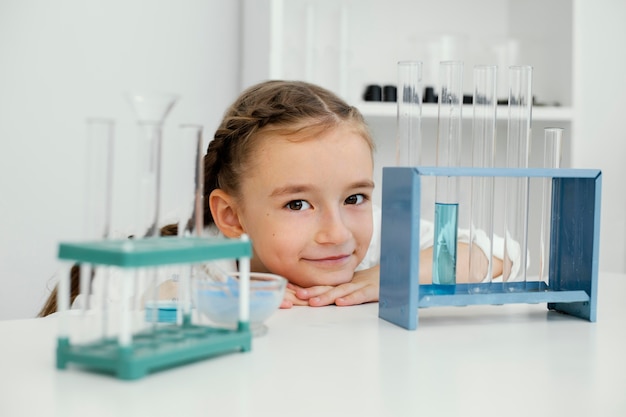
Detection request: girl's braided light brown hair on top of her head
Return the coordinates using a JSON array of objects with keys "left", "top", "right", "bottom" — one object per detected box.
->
[{"left": 204, "top": 80, "right": 374, "bottom": 225}]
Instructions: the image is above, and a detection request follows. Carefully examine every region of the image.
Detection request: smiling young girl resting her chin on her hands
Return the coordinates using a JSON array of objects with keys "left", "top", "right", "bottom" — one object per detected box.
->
[{"left": 40, "top": 81, "right": 502, "bottom": 315}]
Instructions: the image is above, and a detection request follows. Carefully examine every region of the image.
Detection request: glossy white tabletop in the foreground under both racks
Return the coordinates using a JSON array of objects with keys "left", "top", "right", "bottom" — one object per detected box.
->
[{"left": 0, "top": 274, "right": 626, "bottom": 417}]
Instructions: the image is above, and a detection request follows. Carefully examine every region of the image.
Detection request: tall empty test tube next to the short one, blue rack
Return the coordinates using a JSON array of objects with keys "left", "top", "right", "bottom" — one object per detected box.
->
[{"left": 502, "top": 66, "right": 532, "bottom": 291}]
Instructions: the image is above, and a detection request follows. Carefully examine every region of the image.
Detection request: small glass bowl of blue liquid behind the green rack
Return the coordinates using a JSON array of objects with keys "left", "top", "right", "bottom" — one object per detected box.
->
[{"left": 194, "top": 272, "right": 287, "bottom": 336}]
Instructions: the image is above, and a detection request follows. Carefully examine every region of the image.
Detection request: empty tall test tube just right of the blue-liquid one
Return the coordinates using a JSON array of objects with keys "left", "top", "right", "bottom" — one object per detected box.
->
[{"left": 469, "top": 65, "right": 498, "bottom": 292}]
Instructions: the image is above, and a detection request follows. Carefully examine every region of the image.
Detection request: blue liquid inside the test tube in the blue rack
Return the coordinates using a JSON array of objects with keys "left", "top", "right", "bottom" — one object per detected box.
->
[{"left": 433, "top": 203, "right": 459, "bottom": 290}]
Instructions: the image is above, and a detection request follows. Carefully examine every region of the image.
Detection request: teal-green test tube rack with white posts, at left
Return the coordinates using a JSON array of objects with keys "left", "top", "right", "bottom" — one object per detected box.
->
[{"left": 56, "top": 237, "right": 252, "bottom": 380}]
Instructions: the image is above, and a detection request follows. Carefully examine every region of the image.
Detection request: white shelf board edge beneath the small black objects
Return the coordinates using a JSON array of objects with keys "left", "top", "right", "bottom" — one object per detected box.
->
[{"left": 356, "top": 101, "right": 573, "bottom": 122}]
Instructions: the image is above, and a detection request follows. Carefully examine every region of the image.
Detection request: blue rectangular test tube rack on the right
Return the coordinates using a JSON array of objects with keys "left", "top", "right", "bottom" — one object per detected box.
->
[{"left": 378, "top": 167, "right": 602, "bottom": 330}]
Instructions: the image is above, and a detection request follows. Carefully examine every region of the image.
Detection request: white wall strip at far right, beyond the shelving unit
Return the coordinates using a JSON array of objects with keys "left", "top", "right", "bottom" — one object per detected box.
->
[{"left": 572, "top": 0, "right": 626, "bottom": 272}]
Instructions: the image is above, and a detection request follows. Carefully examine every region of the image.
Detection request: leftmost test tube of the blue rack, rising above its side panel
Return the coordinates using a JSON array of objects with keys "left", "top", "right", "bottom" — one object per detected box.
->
[{"left": 396, "top": 61, "right": 422, "bottom": 166}]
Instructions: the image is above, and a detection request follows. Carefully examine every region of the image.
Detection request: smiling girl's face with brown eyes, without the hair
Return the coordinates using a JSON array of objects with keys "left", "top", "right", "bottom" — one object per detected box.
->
[{"left": 237, "top": 125, "right": 374, "bottom": 287}]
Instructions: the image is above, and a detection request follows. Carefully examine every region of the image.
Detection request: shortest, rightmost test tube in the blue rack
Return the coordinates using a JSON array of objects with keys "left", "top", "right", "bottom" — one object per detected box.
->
[{"left": 539, "top": 127, "right": 563, "bottom": 285}]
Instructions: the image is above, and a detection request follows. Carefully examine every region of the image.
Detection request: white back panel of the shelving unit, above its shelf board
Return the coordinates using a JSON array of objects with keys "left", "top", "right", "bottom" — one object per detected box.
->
[{"left": 260, "top": 0, "right": 572, "bottom": 106}]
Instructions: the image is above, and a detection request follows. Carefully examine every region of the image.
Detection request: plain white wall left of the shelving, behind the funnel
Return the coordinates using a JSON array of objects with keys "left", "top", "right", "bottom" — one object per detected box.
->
[{"left": 0, "top": 0, "right": 240, "bottom": 319}]
